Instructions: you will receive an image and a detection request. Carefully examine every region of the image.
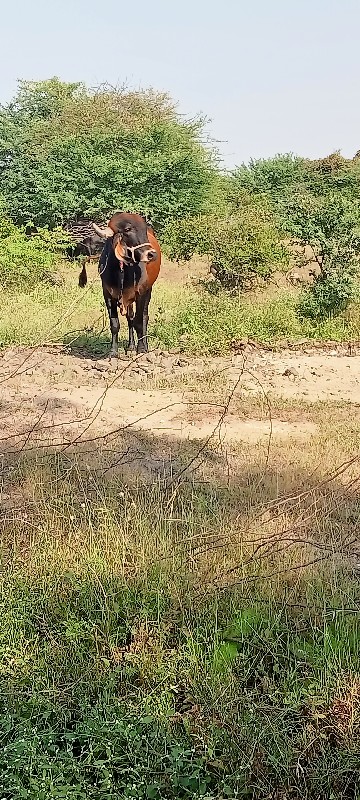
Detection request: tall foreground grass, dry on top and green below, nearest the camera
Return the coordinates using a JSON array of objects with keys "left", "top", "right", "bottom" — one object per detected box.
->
[{"left": 0, "top": 420, "right": 360, "bottom": 800}]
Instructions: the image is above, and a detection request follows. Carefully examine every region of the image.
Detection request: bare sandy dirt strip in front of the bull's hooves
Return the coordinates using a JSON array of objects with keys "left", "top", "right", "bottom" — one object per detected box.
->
[{"left": 0, "top": 346, "right": 360, "bottom": 460}]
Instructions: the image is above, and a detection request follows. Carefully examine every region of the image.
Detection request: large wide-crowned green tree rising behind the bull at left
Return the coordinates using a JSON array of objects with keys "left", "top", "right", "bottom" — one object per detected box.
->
[{"left": 0, "top": 78, "right": 215, "bottom": 227}]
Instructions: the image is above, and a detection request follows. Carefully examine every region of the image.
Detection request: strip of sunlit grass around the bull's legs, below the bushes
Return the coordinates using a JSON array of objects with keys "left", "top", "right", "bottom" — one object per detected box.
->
[{"left": 0, "top": 271, "right": 360, "bottom": 354}]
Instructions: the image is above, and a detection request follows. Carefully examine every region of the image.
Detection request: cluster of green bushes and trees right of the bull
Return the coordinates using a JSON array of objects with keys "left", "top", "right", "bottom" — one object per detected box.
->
[{"left": 165, "top": 153, "right": 360, "bottom": 304}]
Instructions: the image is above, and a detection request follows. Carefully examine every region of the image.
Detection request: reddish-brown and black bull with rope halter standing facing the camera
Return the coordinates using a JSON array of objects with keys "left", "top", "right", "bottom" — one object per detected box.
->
[{"left": 79, "top": 211, "right": 161, "bottom": 356}]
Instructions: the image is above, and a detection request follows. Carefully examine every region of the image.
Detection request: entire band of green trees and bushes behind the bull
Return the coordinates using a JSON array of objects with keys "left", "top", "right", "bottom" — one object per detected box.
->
[{"left": 0, "top": 78, "right": 360, "bottom": 310}]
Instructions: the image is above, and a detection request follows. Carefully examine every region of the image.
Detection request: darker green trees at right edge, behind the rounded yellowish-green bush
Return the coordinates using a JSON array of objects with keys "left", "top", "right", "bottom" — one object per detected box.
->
[{"left": 232, "top": 153, "right": 360, "bottom": 319}]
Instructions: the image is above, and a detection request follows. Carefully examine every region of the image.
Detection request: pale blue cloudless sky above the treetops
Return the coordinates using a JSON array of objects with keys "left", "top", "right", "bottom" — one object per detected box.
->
[{"left": 0, "top": 0, "right": 360, "bottom": 167}]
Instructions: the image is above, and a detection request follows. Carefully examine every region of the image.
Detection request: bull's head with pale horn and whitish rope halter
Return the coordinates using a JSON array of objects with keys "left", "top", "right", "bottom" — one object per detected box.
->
[{"left": 93, "top": 211, "right": 158, "bottom": 294}]
